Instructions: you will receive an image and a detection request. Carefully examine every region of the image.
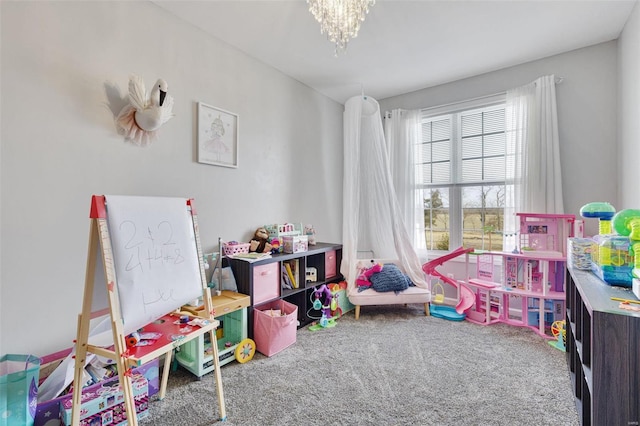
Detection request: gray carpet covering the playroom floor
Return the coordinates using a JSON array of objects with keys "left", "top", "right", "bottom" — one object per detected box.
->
[{"left": 141, "top": 305, "right": 579, "bottom": 426}]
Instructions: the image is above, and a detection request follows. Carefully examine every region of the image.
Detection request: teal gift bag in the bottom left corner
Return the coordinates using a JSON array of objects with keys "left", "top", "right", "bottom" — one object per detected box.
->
[{"left": 0, "top": 354, "right": 40, "bottom": 426}]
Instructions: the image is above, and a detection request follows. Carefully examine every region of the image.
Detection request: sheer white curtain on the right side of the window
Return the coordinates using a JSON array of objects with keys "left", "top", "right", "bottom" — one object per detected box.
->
[{"left": 504, "top": 75, "right": 564, "bottom": 250}]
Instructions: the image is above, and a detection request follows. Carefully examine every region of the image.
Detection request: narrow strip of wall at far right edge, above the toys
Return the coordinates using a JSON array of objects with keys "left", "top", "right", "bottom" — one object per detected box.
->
[{"left": 616, "top": 2, "right": 640, "bottom": 209}]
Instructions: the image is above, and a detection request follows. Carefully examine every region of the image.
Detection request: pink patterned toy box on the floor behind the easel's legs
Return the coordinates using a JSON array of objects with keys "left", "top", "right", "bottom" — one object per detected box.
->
[{"left": 60, "top": 374, "right": 149, "bottom": 426}]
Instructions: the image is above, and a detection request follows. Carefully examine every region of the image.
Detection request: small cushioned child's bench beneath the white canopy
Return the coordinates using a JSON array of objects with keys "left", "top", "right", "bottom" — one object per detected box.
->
[{"left": 347, "top": 259, "right": 431, "bottom": 319}]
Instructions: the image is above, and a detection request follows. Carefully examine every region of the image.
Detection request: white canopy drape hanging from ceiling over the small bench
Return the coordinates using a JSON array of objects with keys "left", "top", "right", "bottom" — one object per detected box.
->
[{"left": 340, "top": 96, "right": 427, "bottom": 288}]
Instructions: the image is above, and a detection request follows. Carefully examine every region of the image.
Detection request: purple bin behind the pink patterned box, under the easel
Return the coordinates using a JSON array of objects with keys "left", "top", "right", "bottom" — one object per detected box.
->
[{"left": 34, "top": 359, "right": 160, "bottom": 426}]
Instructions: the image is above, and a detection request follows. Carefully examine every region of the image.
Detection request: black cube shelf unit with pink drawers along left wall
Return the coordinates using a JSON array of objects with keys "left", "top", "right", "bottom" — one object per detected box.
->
[{"left": 228, "top": 242, "right": 348, "bottom": 338}]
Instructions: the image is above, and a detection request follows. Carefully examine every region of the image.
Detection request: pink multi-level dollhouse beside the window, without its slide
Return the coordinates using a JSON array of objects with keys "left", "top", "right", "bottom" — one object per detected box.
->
[{"left": 466, "top": 213, "right": 574, "bottom": 338}]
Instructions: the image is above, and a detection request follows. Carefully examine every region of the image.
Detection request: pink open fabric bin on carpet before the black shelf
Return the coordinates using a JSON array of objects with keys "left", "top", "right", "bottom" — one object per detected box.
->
[{"left": 253, "top": 300, "right": 298, "bottom": 356}]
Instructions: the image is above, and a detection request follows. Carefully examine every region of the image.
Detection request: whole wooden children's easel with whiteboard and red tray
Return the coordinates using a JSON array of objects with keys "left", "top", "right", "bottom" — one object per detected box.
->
[{"left": 71, "top": 195, "right": 226, "bottom": 426}]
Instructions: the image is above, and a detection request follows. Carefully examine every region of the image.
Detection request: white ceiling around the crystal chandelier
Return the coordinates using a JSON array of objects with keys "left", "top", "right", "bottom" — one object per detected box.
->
[{"left": 153, "top": 0, "right": 640, "bottom": 103}]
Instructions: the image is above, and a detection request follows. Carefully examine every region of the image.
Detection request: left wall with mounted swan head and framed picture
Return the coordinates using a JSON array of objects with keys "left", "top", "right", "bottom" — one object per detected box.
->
[{"left": 0, "top": 1, "right": 343, "bottom": 355}]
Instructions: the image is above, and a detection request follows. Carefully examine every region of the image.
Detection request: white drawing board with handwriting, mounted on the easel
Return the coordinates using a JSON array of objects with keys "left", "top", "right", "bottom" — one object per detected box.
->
[{"left": 105, "top": 195, "right": 203, "bottom": 334}]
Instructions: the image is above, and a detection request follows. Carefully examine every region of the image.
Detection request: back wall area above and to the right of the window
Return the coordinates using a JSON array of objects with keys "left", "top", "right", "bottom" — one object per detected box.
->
[{"left": 380, "top": 41, "right": 620, "bottom": 238}]
